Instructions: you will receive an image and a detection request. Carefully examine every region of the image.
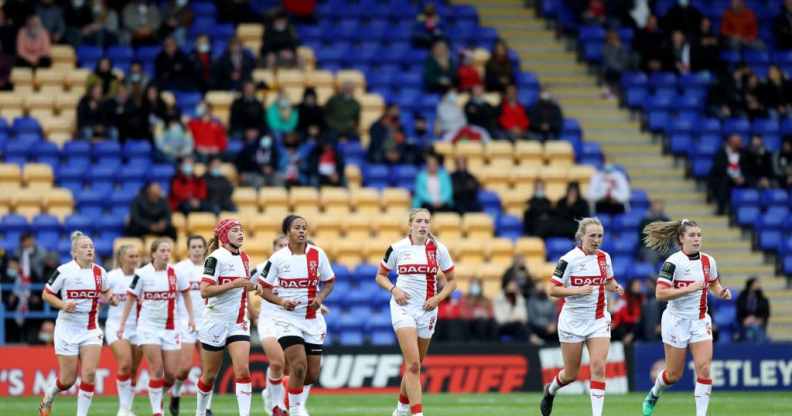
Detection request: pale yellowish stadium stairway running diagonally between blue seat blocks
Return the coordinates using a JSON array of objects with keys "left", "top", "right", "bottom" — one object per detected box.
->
[{"left": 455, "top": 0, "right": 792, "bottom": 340}]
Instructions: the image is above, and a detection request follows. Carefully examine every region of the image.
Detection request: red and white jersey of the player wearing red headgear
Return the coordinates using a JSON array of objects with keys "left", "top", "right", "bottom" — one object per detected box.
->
[{"left": 201, "top": 247, "right": 250, "bottom": 323}]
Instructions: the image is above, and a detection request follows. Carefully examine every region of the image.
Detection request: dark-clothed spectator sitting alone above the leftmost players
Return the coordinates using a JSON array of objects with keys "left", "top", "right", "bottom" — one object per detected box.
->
[{"left": 124, "top": 182, "right": 176, "bottom": 240}]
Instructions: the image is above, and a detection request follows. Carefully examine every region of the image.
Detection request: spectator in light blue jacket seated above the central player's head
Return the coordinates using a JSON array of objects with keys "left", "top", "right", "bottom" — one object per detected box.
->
[{"left": 413, "top": 154, "right": 454, "bottom": 212}]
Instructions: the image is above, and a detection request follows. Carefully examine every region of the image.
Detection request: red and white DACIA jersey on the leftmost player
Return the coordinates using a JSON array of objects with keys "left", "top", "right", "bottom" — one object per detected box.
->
[{"left": 44, "top": 260, "right": 108, "bottom": 329}]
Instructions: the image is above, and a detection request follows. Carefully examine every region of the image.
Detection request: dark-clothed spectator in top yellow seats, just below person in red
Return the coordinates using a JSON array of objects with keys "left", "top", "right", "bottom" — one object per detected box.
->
[{"left": 260, "top": 10, "right": 300, "bottom": 68}]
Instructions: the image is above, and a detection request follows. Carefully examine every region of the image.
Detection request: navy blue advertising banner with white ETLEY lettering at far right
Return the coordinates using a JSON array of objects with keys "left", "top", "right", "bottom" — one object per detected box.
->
[{"left": 633, "top": 343, "right": 792, "bottom": 391}]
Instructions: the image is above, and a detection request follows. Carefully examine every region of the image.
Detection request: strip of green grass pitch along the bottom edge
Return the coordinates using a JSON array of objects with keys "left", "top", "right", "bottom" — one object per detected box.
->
[{"left": 7, "top": 392, "right": 792, "bottom": 416}]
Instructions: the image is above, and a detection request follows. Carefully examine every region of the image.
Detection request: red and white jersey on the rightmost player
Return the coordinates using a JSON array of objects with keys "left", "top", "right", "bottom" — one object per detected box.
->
[{"left": 657, "top": 250, "right": 718, "bottom": 319}]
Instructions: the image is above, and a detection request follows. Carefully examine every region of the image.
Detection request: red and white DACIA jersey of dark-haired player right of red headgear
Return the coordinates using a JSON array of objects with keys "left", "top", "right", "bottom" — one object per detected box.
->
[{"left": 259, "top": 244, "right": 335, "bottom": 319}]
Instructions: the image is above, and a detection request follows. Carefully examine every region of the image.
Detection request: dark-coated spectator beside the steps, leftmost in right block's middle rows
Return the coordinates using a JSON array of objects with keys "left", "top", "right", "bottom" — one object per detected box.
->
[{"left": 709, "top": 133, "right": 746, "bottom": 215}]
